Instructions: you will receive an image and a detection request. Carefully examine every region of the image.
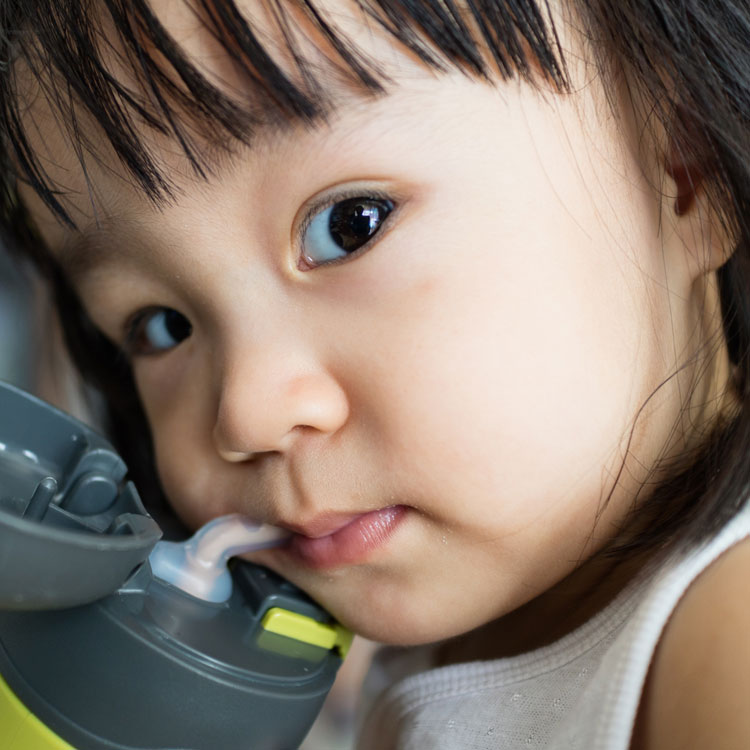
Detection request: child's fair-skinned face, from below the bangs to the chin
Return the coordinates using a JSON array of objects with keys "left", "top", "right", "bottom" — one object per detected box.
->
[{"left": 20, "top": 3, "right": 720, "bottom": 643}]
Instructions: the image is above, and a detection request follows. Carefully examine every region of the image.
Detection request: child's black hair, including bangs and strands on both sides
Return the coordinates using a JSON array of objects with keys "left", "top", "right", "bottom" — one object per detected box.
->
[{"left": 0, "top": 0, "right": 750, "bottom": 553}]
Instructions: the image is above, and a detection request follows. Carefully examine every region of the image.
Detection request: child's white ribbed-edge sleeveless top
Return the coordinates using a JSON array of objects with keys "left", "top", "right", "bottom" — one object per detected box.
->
[{"left": 357, "top": 506, "right": 750, "bottom": 750}]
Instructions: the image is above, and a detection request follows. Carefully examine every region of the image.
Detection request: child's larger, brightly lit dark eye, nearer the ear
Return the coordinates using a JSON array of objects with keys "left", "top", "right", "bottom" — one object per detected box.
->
[{"left": 302, "top": 197, "right": 394, "bottom": 266}]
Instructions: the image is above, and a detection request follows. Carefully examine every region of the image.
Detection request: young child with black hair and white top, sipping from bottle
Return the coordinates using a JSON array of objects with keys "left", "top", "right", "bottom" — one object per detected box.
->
[{"left": 0, "top": 0, "right": 750, "bottom": 750}]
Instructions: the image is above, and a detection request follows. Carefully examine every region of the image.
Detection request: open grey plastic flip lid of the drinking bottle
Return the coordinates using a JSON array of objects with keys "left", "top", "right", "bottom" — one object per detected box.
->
[{"left": 0, "top": 381, "right": 161, "bottom": 610}]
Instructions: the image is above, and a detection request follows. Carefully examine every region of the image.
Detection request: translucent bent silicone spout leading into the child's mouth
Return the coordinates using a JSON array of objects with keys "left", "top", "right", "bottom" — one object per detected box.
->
[{"left": 149, "top": 513, "right": 289, "bottom": 603}]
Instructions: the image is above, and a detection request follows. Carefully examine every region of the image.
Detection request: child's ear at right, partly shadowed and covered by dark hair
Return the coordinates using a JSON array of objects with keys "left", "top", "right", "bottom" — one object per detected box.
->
[{"left": 663, "top": 119, "right": 733, "bottom": 276}]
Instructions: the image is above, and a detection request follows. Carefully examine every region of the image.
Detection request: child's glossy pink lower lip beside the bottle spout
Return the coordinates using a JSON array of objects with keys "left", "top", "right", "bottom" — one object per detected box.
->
[{"left": 287, "top": 505, "right": 406, "bottom": 568}]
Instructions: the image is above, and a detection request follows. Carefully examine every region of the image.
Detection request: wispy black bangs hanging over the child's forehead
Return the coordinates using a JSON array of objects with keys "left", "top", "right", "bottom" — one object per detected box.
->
[{"left": 0, "top": 0, "right": 567, "bottom": 226}]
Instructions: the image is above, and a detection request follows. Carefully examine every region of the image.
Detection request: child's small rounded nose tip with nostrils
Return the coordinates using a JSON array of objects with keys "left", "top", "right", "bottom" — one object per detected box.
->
[{"left": 213, "top": 362, "right": 349, "bottom": 462}]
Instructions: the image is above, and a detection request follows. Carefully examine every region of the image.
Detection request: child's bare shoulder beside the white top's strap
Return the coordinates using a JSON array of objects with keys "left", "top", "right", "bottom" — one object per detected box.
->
[{"left": 631, "top": 539, "right": 750, "bottom": 750}]
